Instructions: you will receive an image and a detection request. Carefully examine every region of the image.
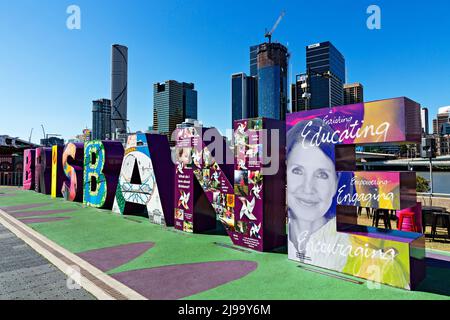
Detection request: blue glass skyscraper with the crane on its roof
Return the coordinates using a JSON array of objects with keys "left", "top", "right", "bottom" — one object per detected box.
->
[{"left": 257, "top": 42, "right": 289, "bottom": 120}]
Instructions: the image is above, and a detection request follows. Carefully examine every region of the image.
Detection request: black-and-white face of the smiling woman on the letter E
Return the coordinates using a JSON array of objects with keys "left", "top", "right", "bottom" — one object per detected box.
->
[{"left": 287, "top": 143, "right": 337, "bottom": 221}]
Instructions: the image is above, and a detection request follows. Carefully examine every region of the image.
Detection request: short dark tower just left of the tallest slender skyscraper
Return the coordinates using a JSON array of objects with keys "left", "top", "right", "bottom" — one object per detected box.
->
[{"left": 92, "top": 99, "right": 111, "bottom": 140}]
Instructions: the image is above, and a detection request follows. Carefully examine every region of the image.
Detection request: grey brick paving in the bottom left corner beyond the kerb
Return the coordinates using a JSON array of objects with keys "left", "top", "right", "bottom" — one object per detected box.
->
[{"left": 0, "top": 224, "right": 95, "bottom": 300}]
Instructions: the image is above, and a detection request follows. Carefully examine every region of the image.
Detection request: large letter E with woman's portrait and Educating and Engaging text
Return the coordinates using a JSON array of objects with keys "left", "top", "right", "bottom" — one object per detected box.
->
[{"left": 286, "top": 98, "right": 425, "bottom": 289}]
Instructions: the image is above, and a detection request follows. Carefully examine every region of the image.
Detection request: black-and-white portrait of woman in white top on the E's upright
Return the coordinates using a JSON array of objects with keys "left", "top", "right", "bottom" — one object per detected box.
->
[{"left": 287, "top": 119, "right": 350, "bottom": 270}]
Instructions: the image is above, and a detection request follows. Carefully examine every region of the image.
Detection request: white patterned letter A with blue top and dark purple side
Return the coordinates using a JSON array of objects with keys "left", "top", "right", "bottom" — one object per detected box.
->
[{"left": 113, "top": 133, "right": 174, "bottom": 226}]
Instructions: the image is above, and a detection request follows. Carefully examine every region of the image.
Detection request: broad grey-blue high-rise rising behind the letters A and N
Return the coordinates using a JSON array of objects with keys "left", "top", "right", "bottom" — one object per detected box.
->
[{"left": 153, "top": 80, "right": 197, "bottom": 141}]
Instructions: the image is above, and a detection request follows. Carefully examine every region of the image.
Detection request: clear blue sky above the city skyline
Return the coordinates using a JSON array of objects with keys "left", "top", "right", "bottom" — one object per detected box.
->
[{"left": 0, "top": 0, "right": 450, "bottom": 142}]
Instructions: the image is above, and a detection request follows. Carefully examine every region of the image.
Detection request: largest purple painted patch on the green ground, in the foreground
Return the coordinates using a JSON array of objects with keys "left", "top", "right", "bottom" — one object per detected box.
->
[{"left": 112, "top": 260, "right": 258, "bottom": 300}]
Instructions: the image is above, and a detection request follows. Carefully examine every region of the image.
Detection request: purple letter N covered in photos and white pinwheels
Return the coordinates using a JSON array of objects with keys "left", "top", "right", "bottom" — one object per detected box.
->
[{"left": 175, "top": 118, "right": 286, "bottom": 251}]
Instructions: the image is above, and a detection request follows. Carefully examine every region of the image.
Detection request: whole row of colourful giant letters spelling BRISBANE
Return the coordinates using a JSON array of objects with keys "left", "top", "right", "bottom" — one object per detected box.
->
[{"left": 23, "top": 97, "right": 425, "bottom": 290}]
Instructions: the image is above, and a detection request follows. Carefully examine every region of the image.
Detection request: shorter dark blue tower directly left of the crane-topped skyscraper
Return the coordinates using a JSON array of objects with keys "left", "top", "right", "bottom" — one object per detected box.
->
[{"left": 231, "top": 72, "right": 258, "bottom": 128}]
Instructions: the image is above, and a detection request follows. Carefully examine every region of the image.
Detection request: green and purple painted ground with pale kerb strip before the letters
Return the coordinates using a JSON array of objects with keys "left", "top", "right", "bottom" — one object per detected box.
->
[{"left": 0, "top": 187, "right": 450, "bottom": 300}]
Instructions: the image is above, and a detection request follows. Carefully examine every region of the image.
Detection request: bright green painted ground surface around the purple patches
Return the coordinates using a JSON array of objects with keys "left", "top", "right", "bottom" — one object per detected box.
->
[{"left": 0, "top": 187, "right": 450, "bottom": 300}]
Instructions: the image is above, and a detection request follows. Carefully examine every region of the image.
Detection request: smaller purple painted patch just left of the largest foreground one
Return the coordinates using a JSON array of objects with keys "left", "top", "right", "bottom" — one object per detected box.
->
[{"left": 77, "top": 242, "right": 155, "bottom": 271}]
